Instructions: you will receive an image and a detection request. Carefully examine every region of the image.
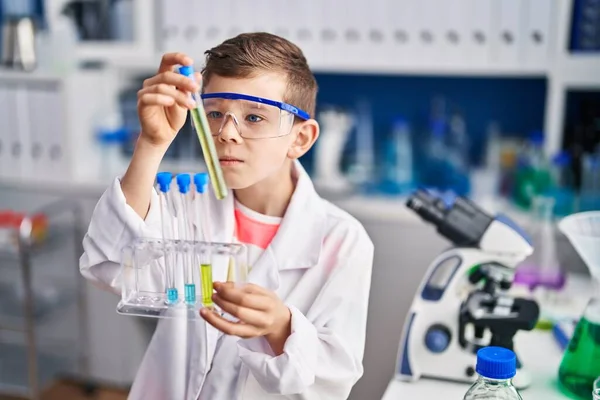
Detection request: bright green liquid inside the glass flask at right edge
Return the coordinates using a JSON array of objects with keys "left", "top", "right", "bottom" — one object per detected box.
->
[{"left": 558, "top": 318, "right": 600, "bottom": 400}]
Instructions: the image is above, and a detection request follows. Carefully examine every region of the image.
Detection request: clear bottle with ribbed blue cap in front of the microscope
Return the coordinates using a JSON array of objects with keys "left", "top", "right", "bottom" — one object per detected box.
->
[{"left": 463, "top": 346, "right": 523, "bottom": 400}]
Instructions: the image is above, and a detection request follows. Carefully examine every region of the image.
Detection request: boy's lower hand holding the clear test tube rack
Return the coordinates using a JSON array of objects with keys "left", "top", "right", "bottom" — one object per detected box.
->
[{"left": 200, "top": 282, "right": 291, "bottom": 354}]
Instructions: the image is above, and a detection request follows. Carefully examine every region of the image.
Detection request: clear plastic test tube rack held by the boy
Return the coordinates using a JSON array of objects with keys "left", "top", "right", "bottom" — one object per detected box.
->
[{"left": 117, "top": 238, "right": 248, "bottom": 319}]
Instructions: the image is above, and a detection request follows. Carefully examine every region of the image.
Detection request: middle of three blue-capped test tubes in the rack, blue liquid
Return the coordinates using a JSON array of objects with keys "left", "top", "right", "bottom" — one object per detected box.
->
[{"left": 177, "top": 174, "right": 196, "bottom": 305}]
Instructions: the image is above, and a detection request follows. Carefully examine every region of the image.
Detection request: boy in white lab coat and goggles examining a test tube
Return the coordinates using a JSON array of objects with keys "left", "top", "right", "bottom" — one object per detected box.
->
[{"left": 80, "top": 33, "right": 373, "bottom": 400}]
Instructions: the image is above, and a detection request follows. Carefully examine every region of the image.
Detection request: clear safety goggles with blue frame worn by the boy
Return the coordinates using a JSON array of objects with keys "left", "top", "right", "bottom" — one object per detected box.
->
[{"left": 201, "top": 93, "right": 310, "bottom": 139}]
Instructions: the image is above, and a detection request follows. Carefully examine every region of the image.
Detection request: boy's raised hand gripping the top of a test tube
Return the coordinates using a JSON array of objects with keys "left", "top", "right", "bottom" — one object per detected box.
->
[{"left": 137, "top": 53, "right": 202, "bottom": 147}]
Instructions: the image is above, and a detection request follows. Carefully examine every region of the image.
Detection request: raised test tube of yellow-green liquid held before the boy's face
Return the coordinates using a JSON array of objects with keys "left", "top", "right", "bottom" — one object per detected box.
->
[{"left": 179, "top": 66, "right": 227, "bottom": 200}]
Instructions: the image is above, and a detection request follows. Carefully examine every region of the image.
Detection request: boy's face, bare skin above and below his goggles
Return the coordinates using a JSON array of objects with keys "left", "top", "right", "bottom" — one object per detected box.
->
[{"left": 204, "top": 72, "right": 304, "bottom": 189}]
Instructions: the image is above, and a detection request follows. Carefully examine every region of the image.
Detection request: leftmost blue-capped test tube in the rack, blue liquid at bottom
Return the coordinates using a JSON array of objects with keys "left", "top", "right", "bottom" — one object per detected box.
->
[{"left": 156, "top": 172, "right": 179, "bottom": 304}]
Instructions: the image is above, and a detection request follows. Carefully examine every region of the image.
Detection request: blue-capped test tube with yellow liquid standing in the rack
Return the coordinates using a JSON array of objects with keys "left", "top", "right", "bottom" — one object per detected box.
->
[{"left": 194, "top": 173, "right": 213, "bottom": 307}]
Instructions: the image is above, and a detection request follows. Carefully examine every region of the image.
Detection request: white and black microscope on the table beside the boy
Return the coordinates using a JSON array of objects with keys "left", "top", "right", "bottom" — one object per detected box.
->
[{"left": 396, "top": 190, "right": 539, "bottom": 389}]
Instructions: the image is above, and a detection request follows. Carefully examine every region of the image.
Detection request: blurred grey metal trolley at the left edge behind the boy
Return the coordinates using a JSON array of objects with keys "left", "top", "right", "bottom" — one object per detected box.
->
[{"left": 0, "top": 200, "right": 89, "bottom": 399}]
